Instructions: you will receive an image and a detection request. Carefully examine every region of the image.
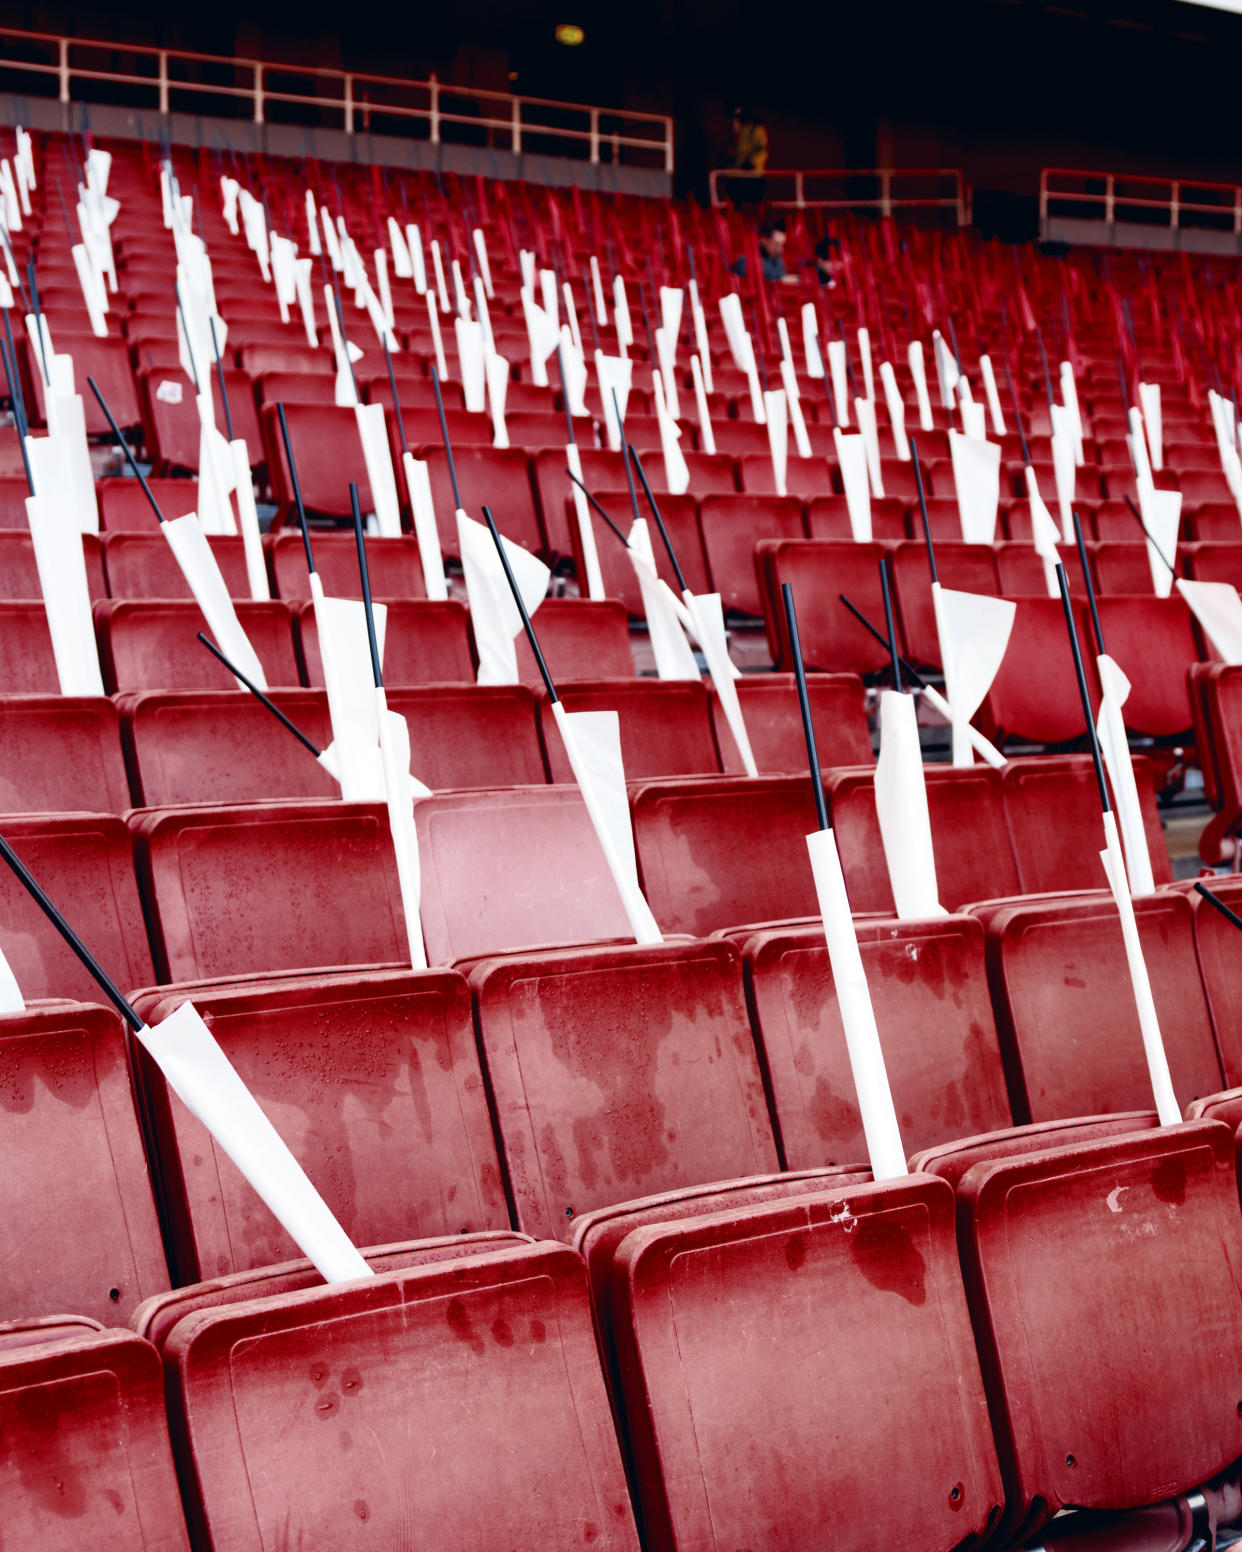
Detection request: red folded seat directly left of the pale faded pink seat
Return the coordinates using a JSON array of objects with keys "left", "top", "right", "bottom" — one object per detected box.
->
[{"left": 130, "top": 802, "right": 410, "bottom": 986}]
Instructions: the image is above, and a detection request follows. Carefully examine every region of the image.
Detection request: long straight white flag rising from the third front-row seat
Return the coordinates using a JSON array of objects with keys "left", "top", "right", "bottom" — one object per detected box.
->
[{"left": 806, "top": 830, "right": 908, "bottom": 1180}]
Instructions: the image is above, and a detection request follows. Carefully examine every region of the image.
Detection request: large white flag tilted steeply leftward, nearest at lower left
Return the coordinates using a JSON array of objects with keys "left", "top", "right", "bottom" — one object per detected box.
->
[{"left": 135, "top": 1003, "right": 374, "bottom": 1282}]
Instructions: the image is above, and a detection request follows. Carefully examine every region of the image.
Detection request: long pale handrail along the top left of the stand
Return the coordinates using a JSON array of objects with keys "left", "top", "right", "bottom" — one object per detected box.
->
[{"left": 0, "top": 26, "right": 674, "bottom": 172}]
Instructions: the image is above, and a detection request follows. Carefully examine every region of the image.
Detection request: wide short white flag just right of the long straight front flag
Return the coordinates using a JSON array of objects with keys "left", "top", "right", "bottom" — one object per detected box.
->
[{"left": 876, "top": 689, "right": 947, "bottom": 922}]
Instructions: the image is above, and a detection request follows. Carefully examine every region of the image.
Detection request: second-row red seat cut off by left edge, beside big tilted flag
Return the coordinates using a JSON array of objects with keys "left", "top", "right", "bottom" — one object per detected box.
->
[{"left": 0, "top": 1005, "right": 168, "bottom": 1322}]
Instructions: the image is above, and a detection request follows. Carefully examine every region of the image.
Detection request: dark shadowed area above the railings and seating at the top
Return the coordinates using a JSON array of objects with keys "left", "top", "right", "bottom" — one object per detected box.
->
[{"left": 5, "top": 0, "right": 1242, "bottom": 236}]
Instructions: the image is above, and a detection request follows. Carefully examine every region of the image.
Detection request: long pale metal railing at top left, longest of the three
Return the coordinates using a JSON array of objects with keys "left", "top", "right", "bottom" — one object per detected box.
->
[{"left": 0, "top": 28, "right": 672, "bottom": 172}]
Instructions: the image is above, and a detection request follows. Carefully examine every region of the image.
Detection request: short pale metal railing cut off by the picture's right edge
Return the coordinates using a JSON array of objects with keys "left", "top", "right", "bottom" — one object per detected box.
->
[{"left": 1039, "top": 168, "right": 1242, "bottom": 236}]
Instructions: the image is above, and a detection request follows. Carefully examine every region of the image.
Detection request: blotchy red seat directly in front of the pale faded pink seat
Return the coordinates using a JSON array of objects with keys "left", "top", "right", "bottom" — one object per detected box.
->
[{"left": 470, "top": 942, "right": 776, "bottom": 1237}]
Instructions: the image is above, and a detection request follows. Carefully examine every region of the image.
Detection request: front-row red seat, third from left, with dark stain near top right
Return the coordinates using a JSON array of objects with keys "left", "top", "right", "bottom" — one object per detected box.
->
[{"left": 612, "top": 1176, "right": 1001, "bottom": 1552}]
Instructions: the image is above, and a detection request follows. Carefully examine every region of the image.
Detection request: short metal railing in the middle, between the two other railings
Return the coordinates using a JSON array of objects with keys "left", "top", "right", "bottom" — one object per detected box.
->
[{"left": 709, "top": 168, "right": 970, "bottom": 227}]
